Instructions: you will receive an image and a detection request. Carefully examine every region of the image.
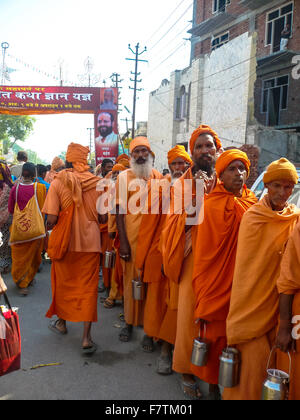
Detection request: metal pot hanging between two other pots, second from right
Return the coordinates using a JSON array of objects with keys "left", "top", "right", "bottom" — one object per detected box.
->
[{"left": 219, "top": 347, "right": 241, "bottom": 388}]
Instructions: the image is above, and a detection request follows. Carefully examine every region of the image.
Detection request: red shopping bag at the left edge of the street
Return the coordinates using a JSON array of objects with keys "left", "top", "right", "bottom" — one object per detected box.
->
[{"left": 0, "top": 293, "right": 21, "bottom": 376}]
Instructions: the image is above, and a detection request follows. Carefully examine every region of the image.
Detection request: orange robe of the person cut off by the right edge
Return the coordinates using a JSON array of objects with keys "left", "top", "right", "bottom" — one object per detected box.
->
[{"left": 277, "top": 222, "right": 300, "bottom": 401}]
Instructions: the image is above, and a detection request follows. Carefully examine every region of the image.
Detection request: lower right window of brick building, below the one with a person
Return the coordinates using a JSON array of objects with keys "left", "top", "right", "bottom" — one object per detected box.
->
[{"left": 261, "top": 75, "right": 289, "bottom": 126}]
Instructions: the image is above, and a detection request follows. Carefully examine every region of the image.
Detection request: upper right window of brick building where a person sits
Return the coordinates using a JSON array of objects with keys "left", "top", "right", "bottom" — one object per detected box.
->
[{"left": 266, "top": 3, "right": 294, "bottom": 53}]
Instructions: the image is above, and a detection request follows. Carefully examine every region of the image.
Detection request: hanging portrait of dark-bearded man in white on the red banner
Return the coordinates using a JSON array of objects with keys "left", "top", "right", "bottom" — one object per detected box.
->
[{"left": 95, "top": 111, "right": 119, "bottom": 164}]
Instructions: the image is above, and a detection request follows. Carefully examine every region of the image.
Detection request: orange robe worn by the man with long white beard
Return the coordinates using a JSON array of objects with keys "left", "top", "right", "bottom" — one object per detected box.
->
[{"left": 116, "top": 169, "right": 162, "bottom": 326}]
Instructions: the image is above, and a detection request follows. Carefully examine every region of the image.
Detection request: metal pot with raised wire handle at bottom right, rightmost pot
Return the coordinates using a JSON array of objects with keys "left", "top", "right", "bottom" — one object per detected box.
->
[{"left": 262, "top": 347, "right": 292, "bottom": 401}]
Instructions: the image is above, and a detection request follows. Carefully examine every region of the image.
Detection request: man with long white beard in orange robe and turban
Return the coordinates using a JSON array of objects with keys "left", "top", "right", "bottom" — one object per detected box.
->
[{"left": 116, "top": 137, "right": 163, "bottom": 351}]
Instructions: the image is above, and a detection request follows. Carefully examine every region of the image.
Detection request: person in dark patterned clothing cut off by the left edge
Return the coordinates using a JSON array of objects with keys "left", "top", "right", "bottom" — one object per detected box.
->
[{"left": 0, "top": 161, "right": 13, "bottom": 274}]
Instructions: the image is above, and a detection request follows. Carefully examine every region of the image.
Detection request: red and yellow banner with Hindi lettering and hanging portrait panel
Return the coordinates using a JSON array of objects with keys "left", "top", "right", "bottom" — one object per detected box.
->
[{"left": 0, "top": 86, "right": 122, "bottom": 164}]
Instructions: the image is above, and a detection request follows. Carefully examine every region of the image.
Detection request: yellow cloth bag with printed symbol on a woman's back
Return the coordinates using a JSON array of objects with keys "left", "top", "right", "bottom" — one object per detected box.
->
[{"left": 9, "top": 183, "right": 46, "bottom": 245}]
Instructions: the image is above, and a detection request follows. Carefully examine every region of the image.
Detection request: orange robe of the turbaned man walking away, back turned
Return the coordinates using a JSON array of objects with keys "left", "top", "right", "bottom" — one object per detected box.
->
[{"left": 43, "top": 170, "right": 101, "bottom": 322}]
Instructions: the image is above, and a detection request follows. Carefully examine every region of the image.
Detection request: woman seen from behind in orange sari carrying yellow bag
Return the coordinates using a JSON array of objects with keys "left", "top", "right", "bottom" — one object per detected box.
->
[{"left": 8, "top": 163, "right": 46, "bottom": 296}]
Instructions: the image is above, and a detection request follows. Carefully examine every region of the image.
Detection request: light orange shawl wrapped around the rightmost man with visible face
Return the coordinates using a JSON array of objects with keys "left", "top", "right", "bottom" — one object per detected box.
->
[{"left": 227, "top": 196, "right": 300, "bottom": 345}]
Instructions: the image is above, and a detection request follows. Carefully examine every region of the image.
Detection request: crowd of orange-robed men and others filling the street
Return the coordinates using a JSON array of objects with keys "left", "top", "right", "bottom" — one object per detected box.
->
[{"left": 0, "top": 125, "right": 300, "bottom": 400}]
